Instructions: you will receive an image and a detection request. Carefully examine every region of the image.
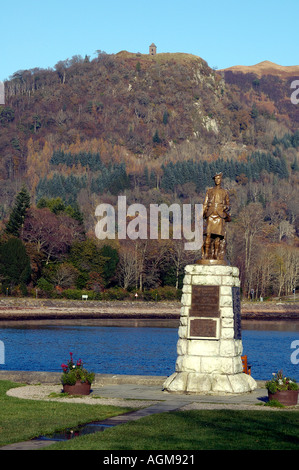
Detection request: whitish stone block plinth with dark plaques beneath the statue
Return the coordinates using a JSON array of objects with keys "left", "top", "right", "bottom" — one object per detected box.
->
[{"left": 163, "top": 264, "right": 257, "bottom": 394}]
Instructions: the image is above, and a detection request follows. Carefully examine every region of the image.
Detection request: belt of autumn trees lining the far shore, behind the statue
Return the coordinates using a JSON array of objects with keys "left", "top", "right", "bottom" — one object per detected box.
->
[{"left": 0, "top": 174, "right": 299, "bottom": 298}]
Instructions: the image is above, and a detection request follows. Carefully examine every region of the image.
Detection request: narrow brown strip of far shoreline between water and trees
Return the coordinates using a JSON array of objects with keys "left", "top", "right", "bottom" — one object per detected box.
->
[{"left": 0, "top": 297, "right": 299, "bottom": 322}]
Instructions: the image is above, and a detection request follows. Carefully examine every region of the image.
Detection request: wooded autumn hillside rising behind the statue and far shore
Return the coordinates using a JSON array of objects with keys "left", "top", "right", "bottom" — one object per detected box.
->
[{"left": 0, "top": 51, "right": 299, "bottom": 297}]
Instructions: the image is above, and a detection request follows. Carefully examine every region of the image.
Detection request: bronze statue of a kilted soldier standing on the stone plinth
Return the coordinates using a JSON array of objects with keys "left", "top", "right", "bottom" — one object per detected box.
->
[{"left": 202, "top": 173, "right": 231, "bottom": 260}]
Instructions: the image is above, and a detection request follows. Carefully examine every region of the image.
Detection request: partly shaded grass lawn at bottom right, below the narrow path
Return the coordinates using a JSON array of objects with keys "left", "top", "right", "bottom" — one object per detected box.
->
[{"left": 46, "top": 410, "right": 299, "bottom": 451}]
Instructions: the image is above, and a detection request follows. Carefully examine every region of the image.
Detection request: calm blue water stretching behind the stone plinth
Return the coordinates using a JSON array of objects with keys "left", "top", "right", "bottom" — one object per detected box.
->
[{"left": 0, "top": 324, "right": 299, "bottom": 381}]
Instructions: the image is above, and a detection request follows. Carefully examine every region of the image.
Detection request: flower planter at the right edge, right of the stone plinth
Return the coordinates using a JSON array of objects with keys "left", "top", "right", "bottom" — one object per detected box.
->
[{"left": 266, "top": 370, "right": 299, "bottom": 406}]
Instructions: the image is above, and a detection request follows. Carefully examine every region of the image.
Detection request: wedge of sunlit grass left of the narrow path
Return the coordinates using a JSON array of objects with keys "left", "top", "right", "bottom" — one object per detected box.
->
[{"left": 0, "top": 380, "right": 132, "bottom": 446}]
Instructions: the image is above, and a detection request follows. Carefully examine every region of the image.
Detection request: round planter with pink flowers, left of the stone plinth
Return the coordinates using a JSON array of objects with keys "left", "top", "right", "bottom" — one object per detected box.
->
[{"left": 61, "top": 353, "right": 95, "bottom": 395}]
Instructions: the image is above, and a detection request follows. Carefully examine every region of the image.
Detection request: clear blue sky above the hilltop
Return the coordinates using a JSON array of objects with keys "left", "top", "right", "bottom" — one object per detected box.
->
[{"left": 0, "top": 0, "right": 299, "bottom": 80}]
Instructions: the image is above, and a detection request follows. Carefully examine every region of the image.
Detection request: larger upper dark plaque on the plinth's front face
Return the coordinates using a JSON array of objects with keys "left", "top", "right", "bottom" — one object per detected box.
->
[{"left": 189, "top": 286, "right": 220, "bottom": 317}]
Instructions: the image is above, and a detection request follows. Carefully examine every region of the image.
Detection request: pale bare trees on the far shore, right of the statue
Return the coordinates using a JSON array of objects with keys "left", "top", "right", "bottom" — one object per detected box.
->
[{"left": 229, "top": 187, "right": 299, "bottom": 299}]
